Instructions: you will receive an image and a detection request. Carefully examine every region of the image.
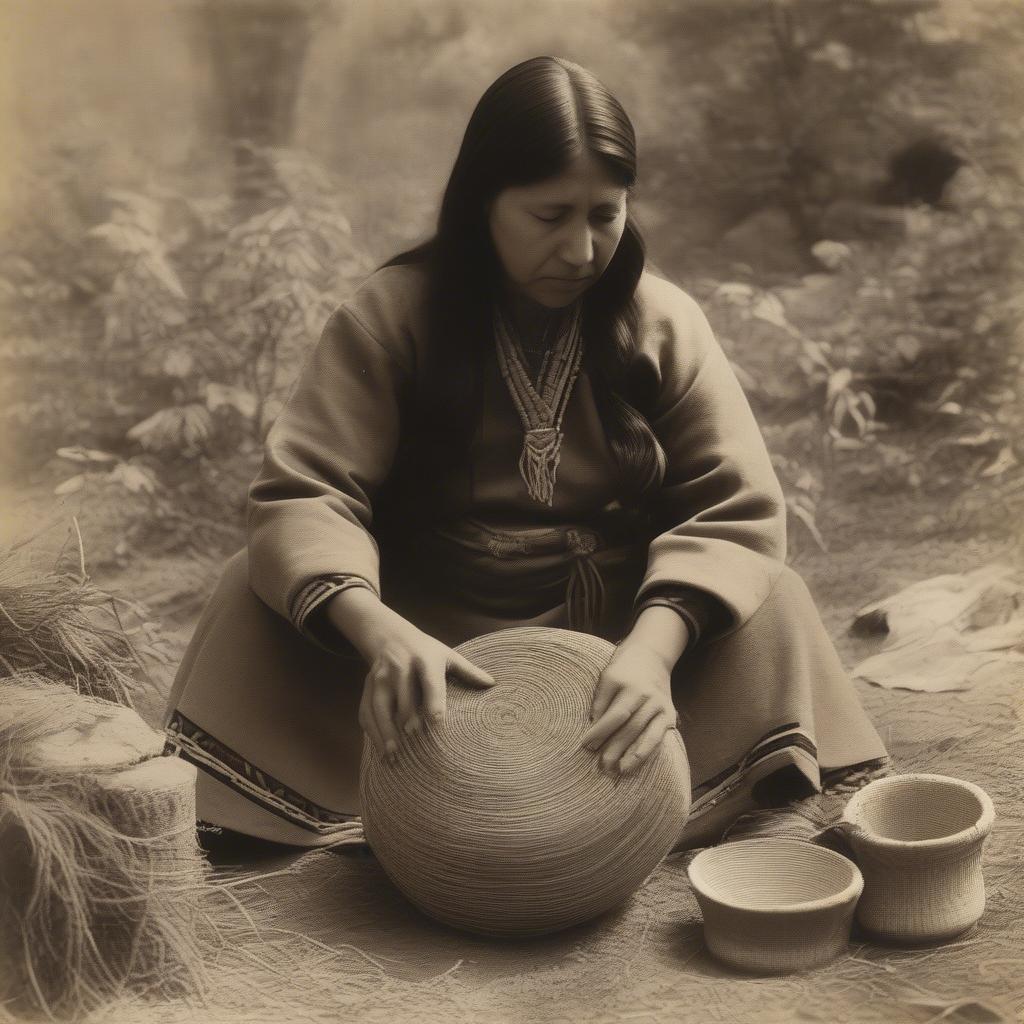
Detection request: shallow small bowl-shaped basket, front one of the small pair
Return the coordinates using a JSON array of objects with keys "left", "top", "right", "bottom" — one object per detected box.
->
[{"left": 688, "top": 839, "right": 864, "bottom": 974}]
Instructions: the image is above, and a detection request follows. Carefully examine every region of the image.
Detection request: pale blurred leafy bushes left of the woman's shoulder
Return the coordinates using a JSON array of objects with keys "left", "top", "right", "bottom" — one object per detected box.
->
[{"left": 0, "top": 143, "right": 373, "bottom": 542}]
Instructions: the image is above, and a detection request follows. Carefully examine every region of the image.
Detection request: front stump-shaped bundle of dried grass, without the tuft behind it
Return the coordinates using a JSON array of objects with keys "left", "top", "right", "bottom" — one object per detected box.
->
[{"left": 0, "top": 674, "right": 204, "bottom": 1020}]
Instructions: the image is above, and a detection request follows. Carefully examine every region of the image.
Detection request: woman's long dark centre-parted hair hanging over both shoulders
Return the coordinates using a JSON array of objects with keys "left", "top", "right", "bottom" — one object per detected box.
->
[{"left": 376, "top": 56, "right": 665, "bottom": 520}]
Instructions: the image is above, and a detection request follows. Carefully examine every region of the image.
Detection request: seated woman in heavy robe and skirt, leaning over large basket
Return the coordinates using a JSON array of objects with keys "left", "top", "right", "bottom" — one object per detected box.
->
[{"left": 167, "top": 57, "right": 886, "bottom": 845}]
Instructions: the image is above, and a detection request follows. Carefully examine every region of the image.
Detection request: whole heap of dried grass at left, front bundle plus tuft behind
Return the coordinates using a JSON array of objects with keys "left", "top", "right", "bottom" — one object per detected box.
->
[{"left": 0, "top": 522, "right": 214, "bottom": 1020}]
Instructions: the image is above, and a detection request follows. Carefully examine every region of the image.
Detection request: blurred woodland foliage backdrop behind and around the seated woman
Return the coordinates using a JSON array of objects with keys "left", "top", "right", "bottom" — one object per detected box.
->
[{"left": 0, "top": 0, "right": 1024, "bottom": 704}]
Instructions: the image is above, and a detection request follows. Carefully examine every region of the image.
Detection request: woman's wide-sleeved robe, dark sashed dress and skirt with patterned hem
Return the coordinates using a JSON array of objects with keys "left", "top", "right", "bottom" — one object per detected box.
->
[{"left": 166, "top": 264, "right": 886, "bottom": 845}]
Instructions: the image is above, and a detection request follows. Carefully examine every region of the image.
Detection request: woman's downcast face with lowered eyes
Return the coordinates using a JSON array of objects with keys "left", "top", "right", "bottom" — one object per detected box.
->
[{"left": 488, "top": 152, "right": 628, "bottom": 309}]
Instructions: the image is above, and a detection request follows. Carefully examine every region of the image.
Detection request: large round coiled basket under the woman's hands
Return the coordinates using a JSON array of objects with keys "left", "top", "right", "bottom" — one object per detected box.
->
[{"left": 359, "top": 627, "right": 690, "bottom": 936}]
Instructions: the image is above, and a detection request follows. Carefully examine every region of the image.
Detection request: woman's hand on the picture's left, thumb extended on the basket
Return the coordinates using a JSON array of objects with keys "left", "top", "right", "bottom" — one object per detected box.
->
[{"left": 359, "top": 620, "right": 495, "bottom": 760}]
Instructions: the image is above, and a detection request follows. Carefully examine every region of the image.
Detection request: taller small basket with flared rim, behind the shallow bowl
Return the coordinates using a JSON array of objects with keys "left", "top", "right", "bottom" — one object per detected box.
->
[{"left": 840, "top": 774, "right": 995, "bottom": 943}]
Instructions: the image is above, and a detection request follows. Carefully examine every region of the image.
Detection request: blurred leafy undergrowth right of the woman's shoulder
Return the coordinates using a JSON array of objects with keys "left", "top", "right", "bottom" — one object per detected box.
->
[{"left": 700, "top": 164, "right": 1024, "bottom": 545}]
